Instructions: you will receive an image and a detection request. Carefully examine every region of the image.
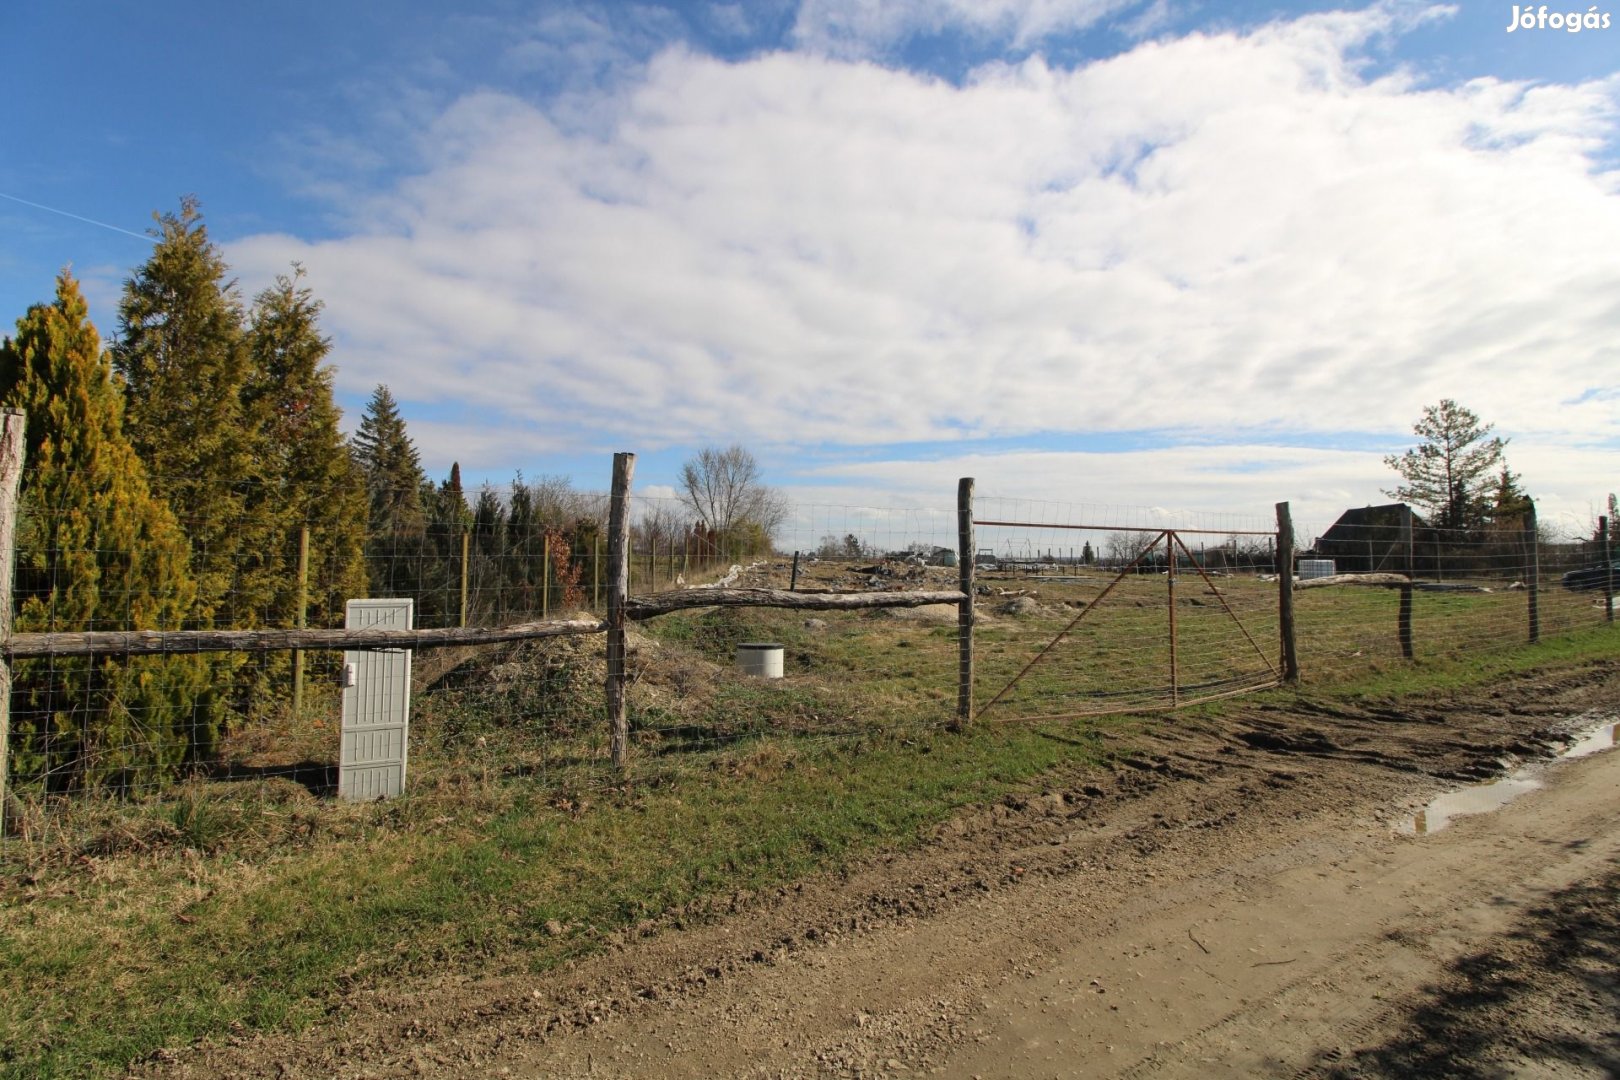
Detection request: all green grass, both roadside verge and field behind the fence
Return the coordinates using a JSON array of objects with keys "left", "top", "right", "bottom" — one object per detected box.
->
[{"left": 0, "top": 580, "right": 1620, "bottom": 1078}]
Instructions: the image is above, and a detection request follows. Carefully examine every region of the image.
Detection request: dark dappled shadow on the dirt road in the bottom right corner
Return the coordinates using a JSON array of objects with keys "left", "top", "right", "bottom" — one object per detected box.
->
[{"left": 1307, "top": 866, "right": 1620, "bottom": 1080}]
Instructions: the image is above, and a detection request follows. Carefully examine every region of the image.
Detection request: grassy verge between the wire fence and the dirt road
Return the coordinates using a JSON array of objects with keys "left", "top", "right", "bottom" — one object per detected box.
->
[{"left": 0, "top": 702, "right": 1098, "bottom": 1077}]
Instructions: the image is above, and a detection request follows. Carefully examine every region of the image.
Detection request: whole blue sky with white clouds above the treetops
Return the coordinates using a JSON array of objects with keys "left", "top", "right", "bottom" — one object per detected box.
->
[{"left": 0, "top": 0, "right": 1620, "bottom": 531}]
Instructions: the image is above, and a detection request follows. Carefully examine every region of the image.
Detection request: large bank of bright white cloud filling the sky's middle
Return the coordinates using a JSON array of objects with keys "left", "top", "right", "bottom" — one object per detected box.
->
[{"left": 228, "top": 2, "right": 1620, "bottom": 527}]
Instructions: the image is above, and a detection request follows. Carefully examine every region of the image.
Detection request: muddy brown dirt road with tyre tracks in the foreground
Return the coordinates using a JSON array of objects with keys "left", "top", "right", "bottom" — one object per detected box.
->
[{"left": 141, "top": 664, "right": 1620, "bottom": 1077}]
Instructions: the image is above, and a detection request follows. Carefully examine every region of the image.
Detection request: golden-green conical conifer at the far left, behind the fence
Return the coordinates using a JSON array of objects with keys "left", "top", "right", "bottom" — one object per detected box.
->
[{"left": 0, "top": 272, "right": 214, "bottom": 790}]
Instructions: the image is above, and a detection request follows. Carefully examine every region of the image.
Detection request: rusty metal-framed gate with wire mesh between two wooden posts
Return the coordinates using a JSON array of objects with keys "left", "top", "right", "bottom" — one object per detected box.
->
[{"left": 974, "top": 497, "right": 1278, "bottom": 721}]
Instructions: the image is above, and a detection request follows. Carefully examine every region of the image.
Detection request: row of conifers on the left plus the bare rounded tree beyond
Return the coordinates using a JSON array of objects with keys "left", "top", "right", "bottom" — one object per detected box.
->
[{"left": 0, "top": 198, "right": 786, "bottom": 790}]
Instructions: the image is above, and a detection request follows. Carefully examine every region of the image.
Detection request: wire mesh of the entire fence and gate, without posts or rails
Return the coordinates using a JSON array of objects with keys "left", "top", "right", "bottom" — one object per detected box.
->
[{"left": 6, "top": 459, "right": 1612, "bottom": 847}]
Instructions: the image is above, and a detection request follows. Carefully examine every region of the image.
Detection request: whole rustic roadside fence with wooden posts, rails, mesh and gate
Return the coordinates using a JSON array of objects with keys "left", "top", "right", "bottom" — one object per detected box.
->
[{"left": 0, "top": 396, "right": 1612, "bottom": 824}]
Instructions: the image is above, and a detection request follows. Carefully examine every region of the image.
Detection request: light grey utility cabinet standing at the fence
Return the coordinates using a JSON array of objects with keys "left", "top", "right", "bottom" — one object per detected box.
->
[{"left": 337, "top": 599, "right": 411, "bottom": 801}]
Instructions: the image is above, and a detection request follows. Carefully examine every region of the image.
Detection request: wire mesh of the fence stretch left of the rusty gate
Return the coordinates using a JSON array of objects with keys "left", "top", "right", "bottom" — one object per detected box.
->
[{"left": 8, "top": 481, "right": 957, "bottom": 845}]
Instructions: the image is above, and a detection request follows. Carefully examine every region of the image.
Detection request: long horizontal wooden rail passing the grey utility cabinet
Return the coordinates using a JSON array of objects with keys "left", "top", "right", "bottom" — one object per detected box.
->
[{"left": 0, "top": 619, "right": 606, "bottom": 661}]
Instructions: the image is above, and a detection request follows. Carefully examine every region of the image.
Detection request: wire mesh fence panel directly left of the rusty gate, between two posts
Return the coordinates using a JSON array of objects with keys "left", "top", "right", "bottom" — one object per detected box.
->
[{"left": 629, "top": 502, "right": 957, "bottom": 771}]
